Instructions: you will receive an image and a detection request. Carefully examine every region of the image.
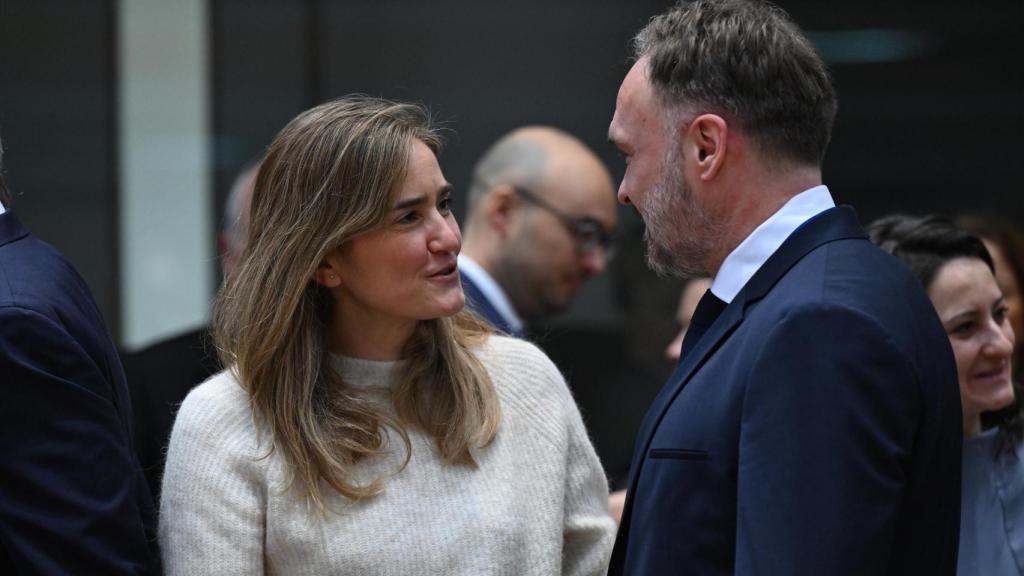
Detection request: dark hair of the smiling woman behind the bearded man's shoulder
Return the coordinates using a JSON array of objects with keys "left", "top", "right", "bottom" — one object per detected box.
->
[{"left": 867, "top": 214, "right": 1024, "bottom": 451}]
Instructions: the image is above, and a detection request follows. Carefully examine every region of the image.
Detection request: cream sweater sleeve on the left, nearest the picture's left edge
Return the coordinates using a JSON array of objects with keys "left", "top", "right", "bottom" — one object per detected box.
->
[{"left": 160, "top": 373, "right": 268, "bottom": 575}]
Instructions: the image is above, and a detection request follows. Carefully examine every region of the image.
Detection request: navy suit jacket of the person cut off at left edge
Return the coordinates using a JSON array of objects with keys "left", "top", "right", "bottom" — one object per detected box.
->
[{"left": 0, "top": 212, "right": 159, "bottom": 574}]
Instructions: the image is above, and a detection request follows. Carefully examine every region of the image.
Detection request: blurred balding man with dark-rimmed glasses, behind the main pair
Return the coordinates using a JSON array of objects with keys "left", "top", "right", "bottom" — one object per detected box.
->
[{"left": 459, "top": 126, "right": 616, "bottom": 335}]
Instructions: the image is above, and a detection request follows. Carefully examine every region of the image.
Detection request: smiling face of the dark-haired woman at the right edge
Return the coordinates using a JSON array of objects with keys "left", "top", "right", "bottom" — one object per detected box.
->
[{"left": 928, "top": 258, "right": 1014, "bottom": 425}]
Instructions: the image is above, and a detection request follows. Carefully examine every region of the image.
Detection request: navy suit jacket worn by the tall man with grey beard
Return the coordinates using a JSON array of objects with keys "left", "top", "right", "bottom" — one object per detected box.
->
[{"left": 609, "top": 208, "right": 963, "bottom": 576}]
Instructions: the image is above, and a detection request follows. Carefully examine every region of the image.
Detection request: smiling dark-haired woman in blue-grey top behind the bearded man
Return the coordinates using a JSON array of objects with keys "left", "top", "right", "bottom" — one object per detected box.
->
[{"left": 868, "top": 215, "right": 1024, "bottom": 576}]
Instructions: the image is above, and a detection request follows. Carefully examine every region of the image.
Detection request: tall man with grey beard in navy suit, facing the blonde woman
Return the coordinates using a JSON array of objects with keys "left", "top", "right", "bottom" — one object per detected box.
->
[{"left": 609, "top": 0, "right": 963, "bottom": 576}]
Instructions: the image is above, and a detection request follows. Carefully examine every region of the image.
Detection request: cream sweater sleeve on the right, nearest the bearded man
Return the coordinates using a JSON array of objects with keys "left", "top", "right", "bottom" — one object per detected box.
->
[{"left": 549, "top": 361, "right": 615, "bottom": 576}]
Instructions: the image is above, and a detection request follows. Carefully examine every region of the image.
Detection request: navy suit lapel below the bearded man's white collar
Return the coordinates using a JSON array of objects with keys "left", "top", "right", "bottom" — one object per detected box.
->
[{"left": 615, "top": 206, "right": 867, "bottom": 541}]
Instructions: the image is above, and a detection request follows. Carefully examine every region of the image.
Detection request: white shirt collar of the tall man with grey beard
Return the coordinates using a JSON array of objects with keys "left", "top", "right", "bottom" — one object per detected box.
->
[{"left": 711, "top": 186, "right": 836, "bottom": 302}]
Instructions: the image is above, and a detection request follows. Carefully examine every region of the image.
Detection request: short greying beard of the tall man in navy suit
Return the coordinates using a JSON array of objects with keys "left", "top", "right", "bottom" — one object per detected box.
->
[{"left": 637, "top": 151, "right": 723, "bottom": 278}]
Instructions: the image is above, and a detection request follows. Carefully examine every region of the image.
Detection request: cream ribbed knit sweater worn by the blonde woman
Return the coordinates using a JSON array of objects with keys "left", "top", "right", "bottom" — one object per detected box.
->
[{"left": 160, "top": 336, "right": 614, "bottom": 576}]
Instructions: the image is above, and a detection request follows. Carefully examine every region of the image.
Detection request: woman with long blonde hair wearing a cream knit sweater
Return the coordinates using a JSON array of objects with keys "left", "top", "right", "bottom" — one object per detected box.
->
[{"left": 160, "top": 96, "right": 614, "bottom": 575}]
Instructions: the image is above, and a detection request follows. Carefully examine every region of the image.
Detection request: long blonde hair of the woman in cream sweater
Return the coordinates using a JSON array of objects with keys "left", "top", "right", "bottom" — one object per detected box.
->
[{"left": 213, "top": 96, "right": 501, "bottom": 511}]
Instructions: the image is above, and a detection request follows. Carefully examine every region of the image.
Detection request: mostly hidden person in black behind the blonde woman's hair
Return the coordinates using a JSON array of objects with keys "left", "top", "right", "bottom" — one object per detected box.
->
[{"left": 122, "top": 156, "right": 260, "bottom": 501}]
